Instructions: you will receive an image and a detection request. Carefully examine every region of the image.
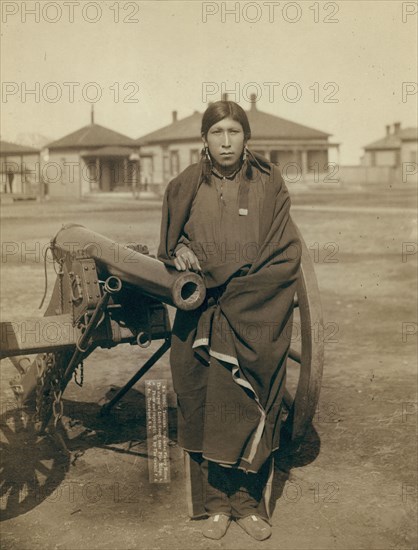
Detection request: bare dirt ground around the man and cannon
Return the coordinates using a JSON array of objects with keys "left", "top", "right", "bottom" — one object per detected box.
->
[{"left": 0, "top": 188, "right": 417, "bottom": 550}]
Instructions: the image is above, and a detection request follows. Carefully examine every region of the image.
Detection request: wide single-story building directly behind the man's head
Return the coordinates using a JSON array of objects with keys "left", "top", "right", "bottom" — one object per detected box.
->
[{"left": 137, "top": 95, "right": 338, "bottom": 188}]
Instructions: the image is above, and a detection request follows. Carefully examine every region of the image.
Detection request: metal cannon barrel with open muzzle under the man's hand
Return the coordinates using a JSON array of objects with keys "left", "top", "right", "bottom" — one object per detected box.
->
[{"left": 51, "top": 224, "right": 206, "bottom": 310}]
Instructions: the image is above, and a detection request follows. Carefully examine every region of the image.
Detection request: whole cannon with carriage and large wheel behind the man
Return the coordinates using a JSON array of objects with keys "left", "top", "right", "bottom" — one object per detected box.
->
[{"left": 0, "top": 224, "right": 324, "bottom": 441}]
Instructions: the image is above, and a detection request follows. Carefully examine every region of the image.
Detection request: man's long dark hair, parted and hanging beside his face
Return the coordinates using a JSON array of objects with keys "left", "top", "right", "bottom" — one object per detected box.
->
[{"left": 200, "top": 100, "right": 253, "bottom": 183}]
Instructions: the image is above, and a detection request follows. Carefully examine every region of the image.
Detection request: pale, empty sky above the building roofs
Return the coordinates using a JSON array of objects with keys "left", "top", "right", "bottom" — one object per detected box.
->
[{"left": 0, "top": 0, "right": 418, "bottom": 164}]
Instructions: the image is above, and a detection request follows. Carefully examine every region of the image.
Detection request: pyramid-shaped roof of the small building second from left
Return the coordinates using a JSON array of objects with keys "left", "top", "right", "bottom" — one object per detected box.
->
[{"left": 46, "top": 123, "right": 137, "bottom": 149}]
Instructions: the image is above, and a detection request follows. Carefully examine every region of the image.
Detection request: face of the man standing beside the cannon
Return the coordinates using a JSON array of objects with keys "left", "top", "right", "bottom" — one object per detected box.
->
[{"left": 203, "top": 118, "right": 245, "bottom": 168}]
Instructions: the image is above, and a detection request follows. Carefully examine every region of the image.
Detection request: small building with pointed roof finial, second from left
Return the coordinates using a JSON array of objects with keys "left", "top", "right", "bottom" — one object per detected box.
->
[{"left": 42, "top": 112, "right": 139, "bottom": 198}]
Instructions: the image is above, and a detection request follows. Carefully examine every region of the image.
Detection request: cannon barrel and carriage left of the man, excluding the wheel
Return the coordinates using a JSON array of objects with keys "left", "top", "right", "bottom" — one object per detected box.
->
[{"left": 0, "top": 224, "right": 205, "bottom": 433}]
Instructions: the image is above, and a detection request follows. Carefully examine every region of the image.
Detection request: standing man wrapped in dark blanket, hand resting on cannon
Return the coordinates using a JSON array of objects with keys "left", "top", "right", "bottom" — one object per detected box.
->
[{"left": 158, "top": 101, "right": 301, "bottom": 540}]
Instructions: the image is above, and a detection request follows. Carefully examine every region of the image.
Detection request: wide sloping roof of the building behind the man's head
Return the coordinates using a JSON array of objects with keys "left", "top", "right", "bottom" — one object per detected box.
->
[{"left": 137, "top": 104, "right": 331, "bottom": 145}]
